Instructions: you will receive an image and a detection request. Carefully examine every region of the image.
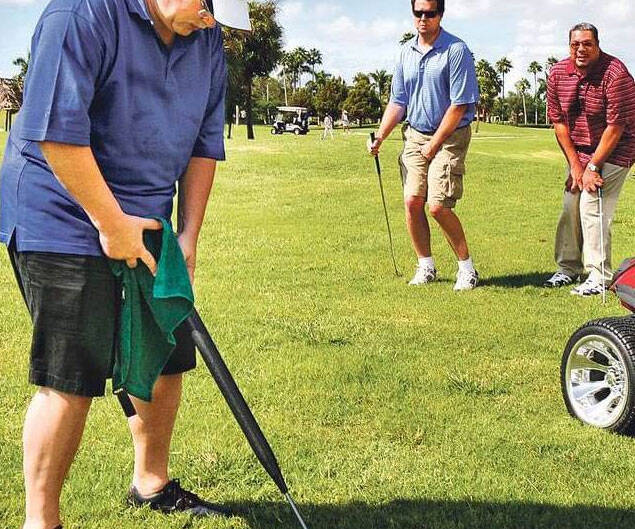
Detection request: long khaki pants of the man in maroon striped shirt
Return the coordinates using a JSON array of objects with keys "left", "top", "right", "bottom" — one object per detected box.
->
[{"left": 555, "top": 163, "right": 629, "bottom": 281}]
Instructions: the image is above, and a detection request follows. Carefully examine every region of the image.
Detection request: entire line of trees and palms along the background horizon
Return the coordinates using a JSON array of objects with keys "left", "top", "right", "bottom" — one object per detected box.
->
[{"left": 4, "top": 0, "right": 557, "bottom": 139}]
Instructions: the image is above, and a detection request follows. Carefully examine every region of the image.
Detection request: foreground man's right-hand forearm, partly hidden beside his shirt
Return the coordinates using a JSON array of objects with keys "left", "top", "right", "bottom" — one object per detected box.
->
[{"left": 178, "top": 158, "right": 216, "bottom": 239}]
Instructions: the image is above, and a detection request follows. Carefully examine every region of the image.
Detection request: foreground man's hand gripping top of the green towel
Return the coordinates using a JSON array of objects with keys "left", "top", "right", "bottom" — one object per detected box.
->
[{"left": 99, "top": 213, "right": 162, "bottom": 275}]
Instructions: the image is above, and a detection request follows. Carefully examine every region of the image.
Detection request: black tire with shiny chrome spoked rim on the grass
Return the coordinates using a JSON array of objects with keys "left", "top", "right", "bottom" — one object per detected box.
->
[{"left": 560, "top": 316, "right": 635, "bottom": 435}]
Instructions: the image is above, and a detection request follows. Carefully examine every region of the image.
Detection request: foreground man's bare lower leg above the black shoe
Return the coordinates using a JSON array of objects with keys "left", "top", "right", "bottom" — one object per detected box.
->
[{"left": 128, "top": 374, "right": 183, "bottom": 496}]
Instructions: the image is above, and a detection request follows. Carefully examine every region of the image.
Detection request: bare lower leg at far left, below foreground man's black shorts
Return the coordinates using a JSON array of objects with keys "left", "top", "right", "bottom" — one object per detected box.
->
[{"left": 23, "top": 388, "right": 92, "bottom": 529}]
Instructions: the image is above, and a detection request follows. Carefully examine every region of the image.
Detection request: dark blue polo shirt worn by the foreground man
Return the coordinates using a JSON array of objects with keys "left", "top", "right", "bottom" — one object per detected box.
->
[{"left": 0, "top": 0, "right": 226, "bottom": 256}]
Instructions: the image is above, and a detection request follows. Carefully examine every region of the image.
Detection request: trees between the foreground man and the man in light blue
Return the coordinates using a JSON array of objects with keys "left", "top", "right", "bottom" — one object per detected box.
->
[{"left": 224, "top": 0, "right": 392, "bottom": 139}]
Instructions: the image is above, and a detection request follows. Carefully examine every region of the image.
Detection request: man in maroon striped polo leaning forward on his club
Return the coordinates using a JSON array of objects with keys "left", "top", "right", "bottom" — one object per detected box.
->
[{"left": 545, "top": 24, "right": 635, "bottom": 296}]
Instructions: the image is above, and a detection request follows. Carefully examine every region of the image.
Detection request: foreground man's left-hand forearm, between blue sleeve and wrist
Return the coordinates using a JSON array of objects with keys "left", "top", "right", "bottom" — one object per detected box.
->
[{"left": 40, "top": 141, "right": 124, "bottom": 232}]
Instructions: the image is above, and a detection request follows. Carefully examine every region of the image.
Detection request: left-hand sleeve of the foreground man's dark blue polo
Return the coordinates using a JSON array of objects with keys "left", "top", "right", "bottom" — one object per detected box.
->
[{"left": 21, "top": 11, "right": 104, "bottom": 145}]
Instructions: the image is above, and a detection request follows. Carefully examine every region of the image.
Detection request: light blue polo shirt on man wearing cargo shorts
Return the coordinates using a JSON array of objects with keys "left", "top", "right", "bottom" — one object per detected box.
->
[{"left": 390, "top": 29, "right": 479, "bottom": 132}]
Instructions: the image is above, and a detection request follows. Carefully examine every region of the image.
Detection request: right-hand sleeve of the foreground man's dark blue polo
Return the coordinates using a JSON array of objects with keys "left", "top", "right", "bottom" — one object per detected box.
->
[{"left": 192, "top": 27, "right": 227, "bottom": 160}]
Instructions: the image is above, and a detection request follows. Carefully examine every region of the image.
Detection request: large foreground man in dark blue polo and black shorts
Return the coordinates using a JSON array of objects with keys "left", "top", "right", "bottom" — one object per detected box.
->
[{"left": 0, "top": 0, "right": 249, "bottom": 529}]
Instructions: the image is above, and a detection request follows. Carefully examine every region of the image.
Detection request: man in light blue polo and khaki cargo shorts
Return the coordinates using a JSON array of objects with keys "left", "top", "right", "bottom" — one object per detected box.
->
[{"left": 369, "top": 0, "right": 479, "bottom": 290}]
